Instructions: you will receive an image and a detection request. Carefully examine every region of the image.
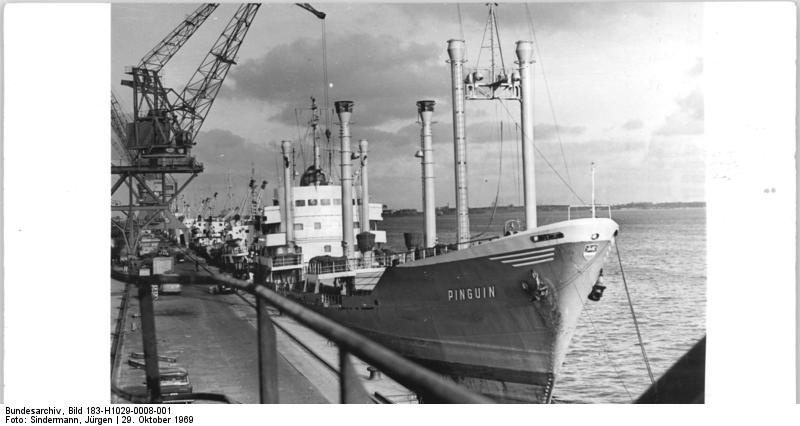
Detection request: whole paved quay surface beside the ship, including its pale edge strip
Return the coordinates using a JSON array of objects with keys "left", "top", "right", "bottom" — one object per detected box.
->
[{"left": 111, "top": 262, "right": 417, "bottom": 404}]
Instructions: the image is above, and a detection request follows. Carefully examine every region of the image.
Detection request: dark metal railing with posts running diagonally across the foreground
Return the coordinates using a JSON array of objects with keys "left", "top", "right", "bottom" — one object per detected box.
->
[{"left": 112, "top": 256, "right": 493, "bottom": 404}]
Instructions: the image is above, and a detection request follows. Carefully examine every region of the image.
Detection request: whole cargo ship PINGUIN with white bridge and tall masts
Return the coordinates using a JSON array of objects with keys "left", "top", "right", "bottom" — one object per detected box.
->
[{"left": 250, "top": 22, "right": 618, "bottom": 403}]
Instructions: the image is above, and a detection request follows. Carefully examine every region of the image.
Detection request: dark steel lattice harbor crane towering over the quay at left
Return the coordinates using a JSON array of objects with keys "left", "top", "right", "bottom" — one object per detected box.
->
[{"left": 111, "top": 3, "right": 261, "bottom": 254}]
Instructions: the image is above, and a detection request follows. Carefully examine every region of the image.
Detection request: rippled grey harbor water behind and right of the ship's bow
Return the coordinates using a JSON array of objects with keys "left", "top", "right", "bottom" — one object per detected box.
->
[{"left": 381, "top": 208, "right": 706, "bottom": 403}]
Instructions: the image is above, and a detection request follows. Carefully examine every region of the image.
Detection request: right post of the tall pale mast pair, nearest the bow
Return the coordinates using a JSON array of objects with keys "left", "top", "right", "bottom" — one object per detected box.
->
[{"left": 516, "top": 41, "right": 536, "bottom": 230}]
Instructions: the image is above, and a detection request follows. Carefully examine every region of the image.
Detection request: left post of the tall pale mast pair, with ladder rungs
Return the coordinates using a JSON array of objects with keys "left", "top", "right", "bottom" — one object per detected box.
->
[{"left": 447, "top": 40, "right": 470, "bottom": 249}]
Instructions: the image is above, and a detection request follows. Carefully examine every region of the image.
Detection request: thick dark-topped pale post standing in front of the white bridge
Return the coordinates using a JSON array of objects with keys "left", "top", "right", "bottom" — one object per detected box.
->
[{"left": 334, "top": 101, "right": 354, "bottom": 259}]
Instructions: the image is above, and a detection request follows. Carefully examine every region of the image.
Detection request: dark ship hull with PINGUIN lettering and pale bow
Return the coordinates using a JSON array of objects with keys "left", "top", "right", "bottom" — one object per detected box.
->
[{"left": 288, "top": 219, "right": 618, "bottom": 403}]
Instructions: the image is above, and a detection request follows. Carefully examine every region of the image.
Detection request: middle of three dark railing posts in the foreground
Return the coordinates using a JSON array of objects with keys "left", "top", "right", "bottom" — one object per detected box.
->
[{"left": 256, "top": 296, "right": 278, "bottom": 404}]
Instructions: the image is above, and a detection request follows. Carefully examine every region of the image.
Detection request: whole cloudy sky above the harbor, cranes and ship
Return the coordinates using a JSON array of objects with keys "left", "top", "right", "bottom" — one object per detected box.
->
[{"left": 111, "top": 3, "right": 705, "bottom": 208}]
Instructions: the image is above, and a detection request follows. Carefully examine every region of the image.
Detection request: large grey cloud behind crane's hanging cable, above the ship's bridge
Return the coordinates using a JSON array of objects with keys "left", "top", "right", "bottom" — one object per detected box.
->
[{"left": 229, "top": 33, "right": 449, "bottom": 126}]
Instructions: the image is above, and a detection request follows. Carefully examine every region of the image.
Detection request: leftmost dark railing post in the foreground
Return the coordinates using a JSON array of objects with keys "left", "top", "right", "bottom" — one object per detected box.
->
[{"left": 137, "top": 278, "right": 161, "bottom": 403}]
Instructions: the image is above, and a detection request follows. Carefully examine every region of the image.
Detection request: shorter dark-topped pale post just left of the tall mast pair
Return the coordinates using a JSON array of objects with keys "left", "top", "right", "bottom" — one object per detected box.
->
[{"left": 417, "top": 101, "right": 436, "bottom": 248}]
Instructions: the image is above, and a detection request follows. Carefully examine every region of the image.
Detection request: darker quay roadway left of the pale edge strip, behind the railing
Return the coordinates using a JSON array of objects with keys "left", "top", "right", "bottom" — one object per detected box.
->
[{"left": 112, "top": 265, "right": 328, "bottom": 404}]
